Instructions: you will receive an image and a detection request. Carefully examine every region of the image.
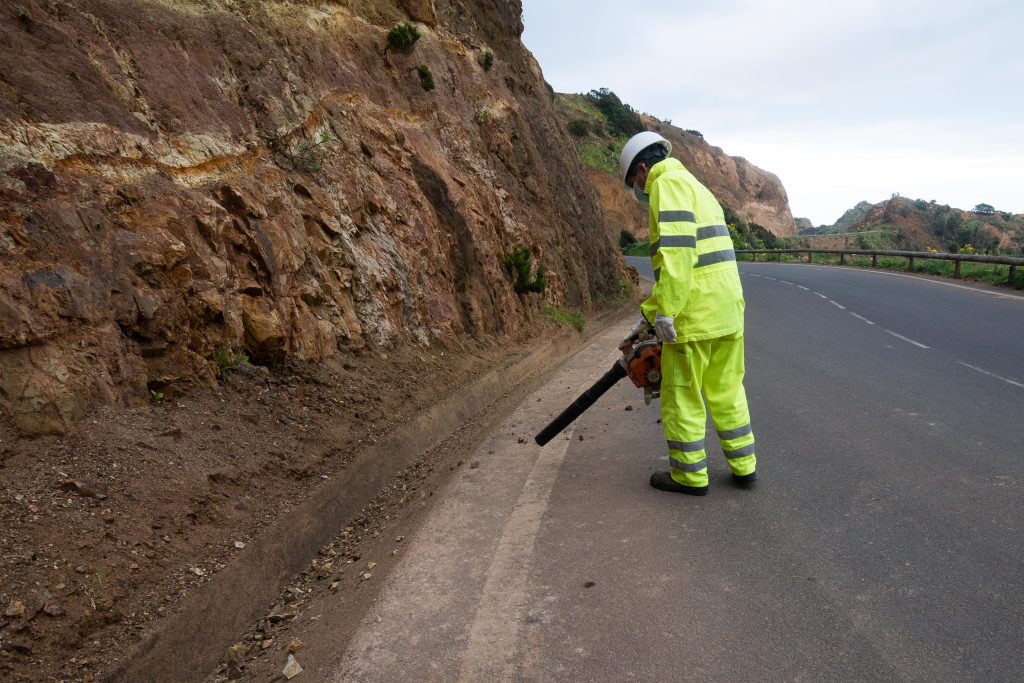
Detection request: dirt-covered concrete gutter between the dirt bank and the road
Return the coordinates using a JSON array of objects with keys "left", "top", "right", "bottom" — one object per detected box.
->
[{"left": 104, "top": 301, "right": 637, "bottom": 683}]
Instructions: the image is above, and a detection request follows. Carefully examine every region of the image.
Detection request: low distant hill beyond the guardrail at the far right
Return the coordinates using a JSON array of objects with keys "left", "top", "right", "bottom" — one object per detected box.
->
[{"left": 801, "top": 196, "right": 1024, "bottom": 254}]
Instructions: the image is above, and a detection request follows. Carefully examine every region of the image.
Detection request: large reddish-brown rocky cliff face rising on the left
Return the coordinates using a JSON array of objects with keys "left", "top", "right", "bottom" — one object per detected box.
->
[{"left": 0, "top": 0, "right": 621, "bottom": 432}]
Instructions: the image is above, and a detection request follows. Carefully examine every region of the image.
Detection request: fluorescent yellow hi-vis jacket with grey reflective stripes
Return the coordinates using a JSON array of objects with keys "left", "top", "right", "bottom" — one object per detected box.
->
[{"left": 640, "top": 158, "right": 744, "bottom": 343}]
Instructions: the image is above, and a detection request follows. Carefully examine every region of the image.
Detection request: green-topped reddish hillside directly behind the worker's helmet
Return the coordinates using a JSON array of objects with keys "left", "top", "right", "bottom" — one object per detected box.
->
[{"left": 556, "top": 90, "right": 797, "bottom": 241}]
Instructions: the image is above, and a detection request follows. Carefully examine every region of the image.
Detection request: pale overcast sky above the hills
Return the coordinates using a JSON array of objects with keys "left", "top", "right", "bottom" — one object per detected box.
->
[{"left": 523, "top": 0, "right": 1024, "bottom": 225}]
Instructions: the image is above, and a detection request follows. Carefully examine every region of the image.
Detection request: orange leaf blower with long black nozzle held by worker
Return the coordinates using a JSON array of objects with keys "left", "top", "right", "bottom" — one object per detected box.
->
[{"left": 534, "top": 322, "right": 662, "bottom": 445}]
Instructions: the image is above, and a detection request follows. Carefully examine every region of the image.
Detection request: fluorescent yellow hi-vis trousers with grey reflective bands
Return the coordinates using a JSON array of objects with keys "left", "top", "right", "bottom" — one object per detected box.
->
[{"left": 662, "top": 332, "right": 757, "bottom": 486}]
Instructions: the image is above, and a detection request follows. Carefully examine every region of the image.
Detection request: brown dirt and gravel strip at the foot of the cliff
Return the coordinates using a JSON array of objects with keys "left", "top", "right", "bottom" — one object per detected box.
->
[{"left": 0, "top": 301, "right": 634, "bottom": 681}]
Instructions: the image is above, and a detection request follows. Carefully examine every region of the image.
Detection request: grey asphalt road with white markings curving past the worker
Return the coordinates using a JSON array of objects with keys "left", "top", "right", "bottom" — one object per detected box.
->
[{"left": 333, "top": 263, "right": 1024, "bottom": 681}]
